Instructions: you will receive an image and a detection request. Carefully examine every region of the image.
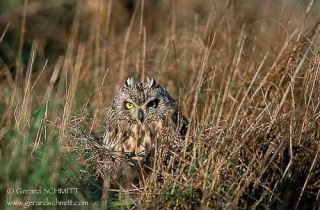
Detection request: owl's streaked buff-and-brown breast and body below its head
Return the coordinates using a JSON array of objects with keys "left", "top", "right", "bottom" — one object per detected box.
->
[{"left": 106, "top": 108, "right": 188, "bottom": 162}]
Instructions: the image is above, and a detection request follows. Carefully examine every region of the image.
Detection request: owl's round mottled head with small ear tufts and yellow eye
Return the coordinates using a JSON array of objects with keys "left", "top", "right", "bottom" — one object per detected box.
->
[{"left": 112, "top": 77, "right": 177, "bottom": 124}]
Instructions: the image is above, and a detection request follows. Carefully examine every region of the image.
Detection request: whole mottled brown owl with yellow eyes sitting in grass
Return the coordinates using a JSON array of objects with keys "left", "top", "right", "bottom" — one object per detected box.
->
[{"left": 104, "top": 77, "right": 188, "bottom": 162}]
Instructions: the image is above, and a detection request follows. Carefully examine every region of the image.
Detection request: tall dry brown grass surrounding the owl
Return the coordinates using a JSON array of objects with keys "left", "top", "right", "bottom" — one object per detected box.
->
[{"left": 0, "top": 0, "right": 320, "bottom": 209}]
